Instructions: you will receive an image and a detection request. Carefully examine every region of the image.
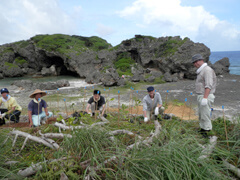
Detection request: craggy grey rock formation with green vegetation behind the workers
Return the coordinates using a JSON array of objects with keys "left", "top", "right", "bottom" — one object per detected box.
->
[{"left": 0, "top": 34, "right": 230, "bottom": 86}]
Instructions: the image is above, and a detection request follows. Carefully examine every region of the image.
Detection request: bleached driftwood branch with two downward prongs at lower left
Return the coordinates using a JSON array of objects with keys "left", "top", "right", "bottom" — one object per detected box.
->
[{"left": 10, "top": 130, "right": 59, "bottom": 150}]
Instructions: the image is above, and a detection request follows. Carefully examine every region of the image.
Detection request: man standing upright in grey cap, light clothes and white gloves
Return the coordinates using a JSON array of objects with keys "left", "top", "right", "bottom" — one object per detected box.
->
[{"left": 192, "top": 54, "right": 217, "bottom": 137}]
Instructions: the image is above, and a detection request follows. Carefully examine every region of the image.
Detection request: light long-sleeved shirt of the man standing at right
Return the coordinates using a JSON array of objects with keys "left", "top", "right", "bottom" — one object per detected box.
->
[{"left": 195, "top": 66, "right": 217, "bottom": 95}]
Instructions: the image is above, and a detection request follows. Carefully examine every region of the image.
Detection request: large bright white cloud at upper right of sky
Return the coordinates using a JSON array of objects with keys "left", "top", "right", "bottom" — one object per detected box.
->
[{"left": 117, "top": 0, "right": 240, "bottom": 50}]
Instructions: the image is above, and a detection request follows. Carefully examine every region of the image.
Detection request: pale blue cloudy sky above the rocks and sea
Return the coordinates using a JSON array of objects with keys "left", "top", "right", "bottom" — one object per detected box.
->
[{"left": 0, "top": 0, "right": 240, "bottom": 51}]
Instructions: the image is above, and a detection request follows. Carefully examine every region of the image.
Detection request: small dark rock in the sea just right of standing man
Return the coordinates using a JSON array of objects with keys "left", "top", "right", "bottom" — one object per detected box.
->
[{"left": 212, "top": 57, "right": 230, "bottom": 75}]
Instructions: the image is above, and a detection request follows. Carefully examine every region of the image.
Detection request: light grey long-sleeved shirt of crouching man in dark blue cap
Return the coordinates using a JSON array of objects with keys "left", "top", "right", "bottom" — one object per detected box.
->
[{"left": 143, "top": 92, "right": 162, "bottom": 111}]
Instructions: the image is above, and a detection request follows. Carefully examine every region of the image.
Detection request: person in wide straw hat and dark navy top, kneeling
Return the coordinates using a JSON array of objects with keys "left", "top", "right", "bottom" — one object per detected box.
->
[{"left": 28, "top": 89, "right": 53, "bottom": 127}]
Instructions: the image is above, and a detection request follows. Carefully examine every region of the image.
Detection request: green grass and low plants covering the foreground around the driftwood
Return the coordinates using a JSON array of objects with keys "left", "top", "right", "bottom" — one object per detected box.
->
[{"left": 0, "top": 105, "right": 240, "bottom": 179}]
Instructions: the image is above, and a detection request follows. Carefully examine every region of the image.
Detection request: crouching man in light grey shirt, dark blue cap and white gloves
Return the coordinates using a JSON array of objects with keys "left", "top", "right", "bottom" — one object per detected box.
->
[{"left": 143, "top": 86, "right": 164, "bottom": 122}]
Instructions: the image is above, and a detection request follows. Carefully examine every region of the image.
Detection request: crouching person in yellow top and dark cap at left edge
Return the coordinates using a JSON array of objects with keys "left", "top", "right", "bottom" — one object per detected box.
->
[{"left": 0, "top": 88, "right": 22, "bottom": 125}]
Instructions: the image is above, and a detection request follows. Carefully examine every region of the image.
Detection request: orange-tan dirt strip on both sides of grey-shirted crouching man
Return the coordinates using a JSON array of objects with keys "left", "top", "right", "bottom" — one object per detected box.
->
[{"left": 107, "top": 104, "right": 198, "bottom": 120}]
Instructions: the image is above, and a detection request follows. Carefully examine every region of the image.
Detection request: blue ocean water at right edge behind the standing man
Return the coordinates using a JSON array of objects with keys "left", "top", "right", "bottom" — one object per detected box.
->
[{"left": 209, "top": 51, "right": 240, "bottom": 75}]
